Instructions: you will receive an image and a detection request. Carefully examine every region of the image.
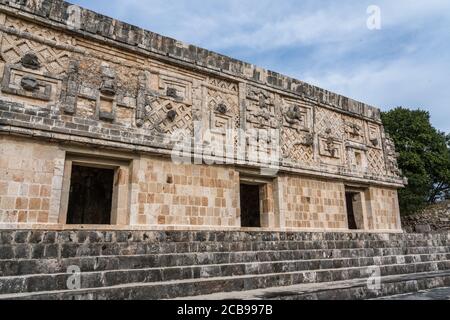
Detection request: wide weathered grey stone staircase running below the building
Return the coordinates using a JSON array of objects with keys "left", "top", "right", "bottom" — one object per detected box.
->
[{"left": 0, "top": 231, "right": 450, "bottom": 299}]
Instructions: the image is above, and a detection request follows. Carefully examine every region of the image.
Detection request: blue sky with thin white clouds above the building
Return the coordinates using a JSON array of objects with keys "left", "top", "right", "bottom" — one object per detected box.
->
[{"left": 69, "top": 0, "right": 450, "bottom": 132}]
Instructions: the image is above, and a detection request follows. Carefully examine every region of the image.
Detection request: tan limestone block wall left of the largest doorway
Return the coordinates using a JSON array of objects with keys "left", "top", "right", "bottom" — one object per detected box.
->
[{"left": 0, "top": 136, "right": 64, "bottom": 224}]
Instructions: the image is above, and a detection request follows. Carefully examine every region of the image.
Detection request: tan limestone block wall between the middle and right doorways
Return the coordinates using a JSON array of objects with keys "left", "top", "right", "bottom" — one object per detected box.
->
[{"left": 278, "top": 176, "right": 347, "bottom": 229}]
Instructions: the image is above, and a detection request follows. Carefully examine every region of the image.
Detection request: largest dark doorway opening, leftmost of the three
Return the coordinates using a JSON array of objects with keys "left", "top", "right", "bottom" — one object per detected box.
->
[{"left": 67, "top": 165, "right": 114, "bottom": 224}]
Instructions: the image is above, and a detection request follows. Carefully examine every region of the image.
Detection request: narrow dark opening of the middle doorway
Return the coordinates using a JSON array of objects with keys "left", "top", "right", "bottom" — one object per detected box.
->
[{"left": 241, "top": 184, "right": 261, "bottom": 228}]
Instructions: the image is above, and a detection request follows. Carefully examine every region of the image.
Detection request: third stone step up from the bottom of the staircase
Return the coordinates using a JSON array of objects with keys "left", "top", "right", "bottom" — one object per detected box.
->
[{"left": 0, "top": 256, "right": 450, "bottom": 294}]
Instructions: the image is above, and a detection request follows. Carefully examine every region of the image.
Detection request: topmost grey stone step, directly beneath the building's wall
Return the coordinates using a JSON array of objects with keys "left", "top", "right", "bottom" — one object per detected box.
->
[{"left": 0, "top": 230, "right": 450, "bottom": 244}]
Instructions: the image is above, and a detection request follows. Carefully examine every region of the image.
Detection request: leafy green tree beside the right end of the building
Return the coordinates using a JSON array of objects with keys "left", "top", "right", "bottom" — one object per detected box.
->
[{"left": 382, "top": 107, "right": 450, "bottom": 215}]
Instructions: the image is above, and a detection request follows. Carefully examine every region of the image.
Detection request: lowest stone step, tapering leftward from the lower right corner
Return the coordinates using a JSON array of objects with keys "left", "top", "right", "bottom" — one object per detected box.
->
[{"left": 175, "top": 271, "right": 450, "bottom": 301}]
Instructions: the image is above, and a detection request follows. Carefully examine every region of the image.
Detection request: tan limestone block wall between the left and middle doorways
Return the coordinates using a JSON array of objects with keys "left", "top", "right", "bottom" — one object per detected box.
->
[{"left": 131, "top": 156, "right": 240, "bottom": 228}]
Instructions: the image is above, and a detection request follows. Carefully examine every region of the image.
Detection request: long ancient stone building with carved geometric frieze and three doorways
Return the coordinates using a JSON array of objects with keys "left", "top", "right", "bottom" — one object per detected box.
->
[{"left": 0, "top": 0, "right": 405, "bottom": 232}]
